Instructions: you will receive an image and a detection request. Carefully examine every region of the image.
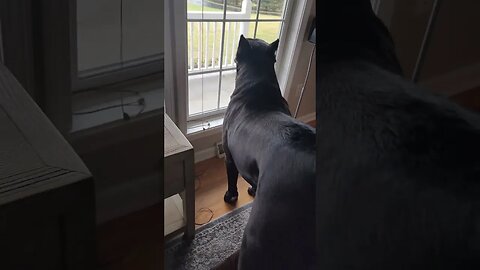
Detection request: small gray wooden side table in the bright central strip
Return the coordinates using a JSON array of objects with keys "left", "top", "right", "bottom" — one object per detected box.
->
[{"left": 164, "top": 114, "right": 195, "bottom": 240}]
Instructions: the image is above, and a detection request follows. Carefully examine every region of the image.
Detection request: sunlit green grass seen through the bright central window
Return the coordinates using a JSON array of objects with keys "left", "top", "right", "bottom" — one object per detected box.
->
[{"left": 187, "top": 3, "right": 281, "bottom": 67}]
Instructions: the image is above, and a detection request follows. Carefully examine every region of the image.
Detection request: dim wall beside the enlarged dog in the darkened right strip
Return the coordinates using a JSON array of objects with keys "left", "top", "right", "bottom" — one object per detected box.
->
[{"left": 379, "top": 0, "right": 480, "bottom": 96}]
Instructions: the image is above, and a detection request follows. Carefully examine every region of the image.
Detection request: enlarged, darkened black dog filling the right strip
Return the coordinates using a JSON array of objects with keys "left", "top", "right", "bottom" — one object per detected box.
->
[{"left": 316, "top": 0, "right": 480, "bottom": 270}]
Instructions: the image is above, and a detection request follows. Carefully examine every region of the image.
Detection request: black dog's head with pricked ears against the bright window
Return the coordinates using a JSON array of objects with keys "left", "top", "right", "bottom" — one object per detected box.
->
[{"left": 235, "top": 35, "right": 278, "bottom": 75}]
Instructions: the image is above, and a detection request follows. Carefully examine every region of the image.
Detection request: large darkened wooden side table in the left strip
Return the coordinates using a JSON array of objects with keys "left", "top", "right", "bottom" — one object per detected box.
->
[{"left": 0, "top": 64, "right": 96, "bottom": 270}]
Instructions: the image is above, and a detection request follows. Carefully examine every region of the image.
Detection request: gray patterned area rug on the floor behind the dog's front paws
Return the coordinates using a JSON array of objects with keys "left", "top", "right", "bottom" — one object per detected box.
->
[{"left": 165, "top": 203, "right": 252, "bottom": 270}]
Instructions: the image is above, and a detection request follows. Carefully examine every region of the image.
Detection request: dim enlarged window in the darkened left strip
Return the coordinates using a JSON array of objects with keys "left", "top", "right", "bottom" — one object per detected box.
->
[{"left": 70, "top": 0, "right": 164, "bottom": 132}]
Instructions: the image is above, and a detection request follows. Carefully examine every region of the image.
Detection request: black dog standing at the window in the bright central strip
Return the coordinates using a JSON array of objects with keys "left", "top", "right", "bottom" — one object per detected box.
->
[{"left": 223, "top": 36, "right": 315, "bottom": 270}]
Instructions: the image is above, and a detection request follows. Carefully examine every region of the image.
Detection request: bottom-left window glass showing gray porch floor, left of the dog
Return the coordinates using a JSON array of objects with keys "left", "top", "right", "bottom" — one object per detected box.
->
[{"left": 188, "top": 72, "right": 220, "bottom": 115}]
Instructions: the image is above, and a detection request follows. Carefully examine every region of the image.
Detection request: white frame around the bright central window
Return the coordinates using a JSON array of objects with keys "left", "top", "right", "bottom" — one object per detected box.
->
[{"left": 165, "top": 0, "right": 315, "bottom": 134}]
